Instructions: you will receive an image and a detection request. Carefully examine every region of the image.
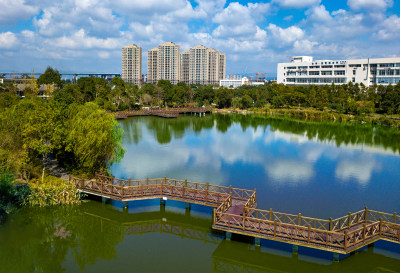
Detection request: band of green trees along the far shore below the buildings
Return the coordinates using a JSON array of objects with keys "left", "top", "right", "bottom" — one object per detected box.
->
[{"left": 0, "top": 67, "right": 400, "bottom": 115}]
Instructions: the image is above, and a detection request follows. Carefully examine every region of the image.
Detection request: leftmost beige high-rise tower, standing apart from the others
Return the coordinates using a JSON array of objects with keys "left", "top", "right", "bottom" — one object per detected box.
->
[{"left": 122, "top": 44, "right": 142, "bottom": 85}]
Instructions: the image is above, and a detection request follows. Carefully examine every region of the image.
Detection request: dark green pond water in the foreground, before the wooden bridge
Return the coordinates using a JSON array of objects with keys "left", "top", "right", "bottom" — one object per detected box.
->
[{"left": 0, "top": 201, "right": 400, "bottom": 272}]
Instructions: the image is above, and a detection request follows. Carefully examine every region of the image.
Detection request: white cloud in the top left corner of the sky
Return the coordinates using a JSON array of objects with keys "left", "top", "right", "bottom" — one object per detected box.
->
[{"left": 0, "top": 0, "right": 39, "bottom": 24}]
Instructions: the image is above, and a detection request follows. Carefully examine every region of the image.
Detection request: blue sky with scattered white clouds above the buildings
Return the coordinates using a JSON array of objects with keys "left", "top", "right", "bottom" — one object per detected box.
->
[{"left": 0, "top": 0, "right": 400, "bottom": 74}]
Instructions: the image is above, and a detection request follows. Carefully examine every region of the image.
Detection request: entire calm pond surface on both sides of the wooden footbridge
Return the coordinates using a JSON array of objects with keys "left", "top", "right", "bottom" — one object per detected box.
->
[{"left": 0, "top": 115, "right": 400, "bottom": 272}]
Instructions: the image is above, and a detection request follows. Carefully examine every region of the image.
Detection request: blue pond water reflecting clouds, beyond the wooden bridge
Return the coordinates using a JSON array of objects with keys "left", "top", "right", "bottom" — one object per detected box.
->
[{"left": 111, "top": 115, "right": 400, "bottom": 218}]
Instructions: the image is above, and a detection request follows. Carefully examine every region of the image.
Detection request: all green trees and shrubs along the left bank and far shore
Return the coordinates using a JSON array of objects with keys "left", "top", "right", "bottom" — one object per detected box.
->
[{"left": 0, "top": 64, "right": 400, "bottom": 217}]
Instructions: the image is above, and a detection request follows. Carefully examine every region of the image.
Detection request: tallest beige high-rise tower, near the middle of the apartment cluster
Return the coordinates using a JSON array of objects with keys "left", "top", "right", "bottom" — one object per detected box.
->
[{"left": 157, "top": 42, "right": 181, "bottom": 84}]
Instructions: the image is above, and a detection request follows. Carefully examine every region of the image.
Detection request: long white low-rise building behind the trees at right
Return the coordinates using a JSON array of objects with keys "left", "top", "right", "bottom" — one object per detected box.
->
[{"left": 277, "top": 56, "right": 400, "bottom": 86}]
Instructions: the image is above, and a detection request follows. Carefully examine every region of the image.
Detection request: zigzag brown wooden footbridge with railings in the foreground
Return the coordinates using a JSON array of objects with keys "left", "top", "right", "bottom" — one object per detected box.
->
[{"left": 69, "top": 175, "right": 400, "bottom": 254}]
